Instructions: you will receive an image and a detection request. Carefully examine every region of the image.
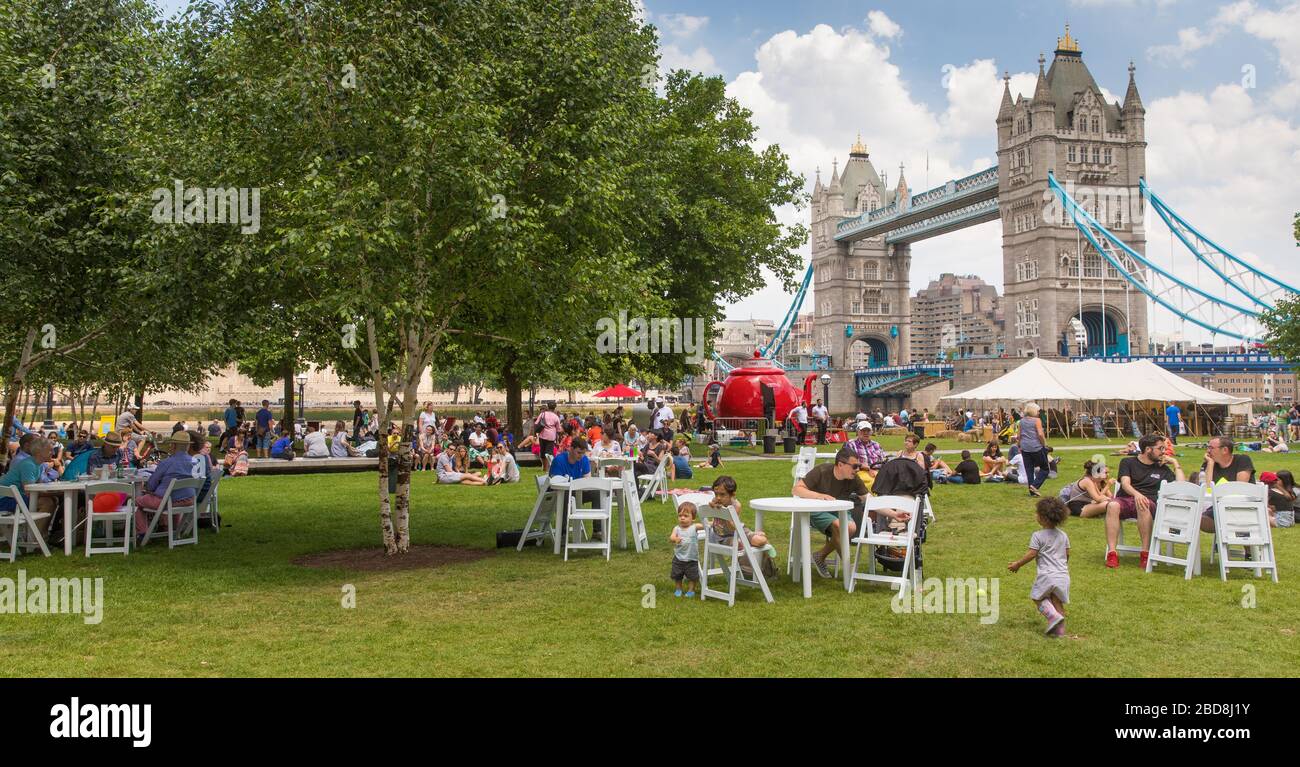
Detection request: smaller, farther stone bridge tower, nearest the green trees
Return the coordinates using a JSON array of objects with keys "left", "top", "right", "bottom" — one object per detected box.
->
[{"left": 811, "top": 135, "right": 911, "bottom": 369}]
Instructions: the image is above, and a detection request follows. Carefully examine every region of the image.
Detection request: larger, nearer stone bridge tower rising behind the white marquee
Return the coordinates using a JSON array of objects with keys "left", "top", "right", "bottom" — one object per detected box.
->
[{"left": 997, "top": 26, "right": 1148, "bottom": 356}]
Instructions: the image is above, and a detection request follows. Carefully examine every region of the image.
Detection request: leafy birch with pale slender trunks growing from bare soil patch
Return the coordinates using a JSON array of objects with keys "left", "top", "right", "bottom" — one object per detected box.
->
[{"left": 195, "top": 0, "right": 654, "bottom": 554}]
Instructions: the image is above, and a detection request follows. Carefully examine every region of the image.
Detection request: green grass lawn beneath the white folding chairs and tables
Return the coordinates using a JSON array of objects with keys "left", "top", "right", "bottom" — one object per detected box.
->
[{"left": 0, "top": 449, "right": 1300, "bottom": 676}]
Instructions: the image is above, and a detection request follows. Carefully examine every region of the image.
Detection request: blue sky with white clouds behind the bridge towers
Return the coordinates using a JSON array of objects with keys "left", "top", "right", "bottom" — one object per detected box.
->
[{"left": 152, "top": 0, "right": 1300, "bottom": 345}]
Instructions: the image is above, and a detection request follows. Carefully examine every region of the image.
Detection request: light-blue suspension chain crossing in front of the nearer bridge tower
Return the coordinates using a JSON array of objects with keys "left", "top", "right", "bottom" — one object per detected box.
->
[{"left": 1048, "top": 174, "right": 1261, "bottom": 342}]
